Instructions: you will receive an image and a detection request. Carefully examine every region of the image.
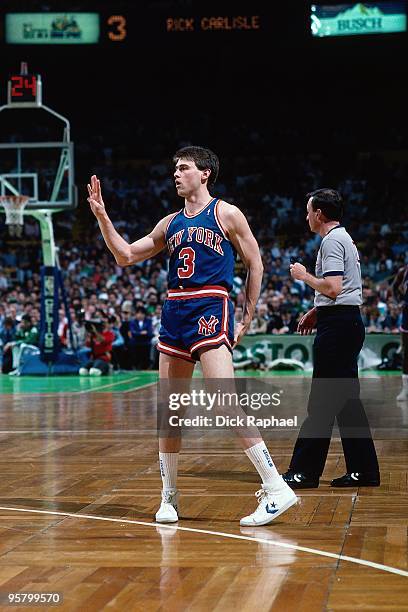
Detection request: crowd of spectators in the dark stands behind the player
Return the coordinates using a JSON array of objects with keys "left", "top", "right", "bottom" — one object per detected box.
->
[{"left": 0, "top": 143, "right": 408, "bottom": 371}]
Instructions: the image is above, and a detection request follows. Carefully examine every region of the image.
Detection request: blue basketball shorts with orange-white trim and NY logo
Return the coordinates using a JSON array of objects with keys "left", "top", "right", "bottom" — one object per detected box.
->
[{"left": 157, "top": 285, "right": 234, "bottom": 363}]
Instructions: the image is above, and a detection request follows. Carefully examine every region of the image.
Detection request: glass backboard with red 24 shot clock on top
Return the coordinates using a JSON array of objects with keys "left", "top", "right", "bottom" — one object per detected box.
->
[{"left": 0, "top": 63, "right": 77, "bottom": 212}]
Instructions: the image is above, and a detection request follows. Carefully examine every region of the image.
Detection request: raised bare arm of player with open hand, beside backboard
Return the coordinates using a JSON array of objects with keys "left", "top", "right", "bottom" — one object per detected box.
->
[{"left": 88, "top": 175, "right": 168, "bottom": 266}]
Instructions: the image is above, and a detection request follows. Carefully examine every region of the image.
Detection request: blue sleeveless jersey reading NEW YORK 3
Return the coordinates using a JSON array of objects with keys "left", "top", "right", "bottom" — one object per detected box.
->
[{"left": 166, "top": 198, "right": 236, "bottom": 291}]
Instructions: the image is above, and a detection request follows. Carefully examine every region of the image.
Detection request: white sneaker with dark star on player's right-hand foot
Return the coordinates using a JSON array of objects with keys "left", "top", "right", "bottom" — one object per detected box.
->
[{"left": 240, "top": 480, "right": 299, "bottom": 527}]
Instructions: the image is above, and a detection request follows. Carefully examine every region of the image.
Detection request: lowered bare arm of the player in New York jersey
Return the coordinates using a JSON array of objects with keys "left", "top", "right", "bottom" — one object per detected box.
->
[{"left": 218, "top": 202, "right": 263, "bottom": 346}]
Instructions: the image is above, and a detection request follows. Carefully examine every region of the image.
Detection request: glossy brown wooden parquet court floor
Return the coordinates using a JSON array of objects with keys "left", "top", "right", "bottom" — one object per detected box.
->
[{"left": 0, "top": 372, "right": 408, "bottom": 612}]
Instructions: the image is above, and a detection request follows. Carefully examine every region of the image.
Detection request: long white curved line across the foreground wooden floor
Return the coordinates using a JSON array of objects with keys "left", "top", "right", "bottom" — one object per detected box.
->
[{"left": 0, "top": 506, "right": 408, "bottom": 578}]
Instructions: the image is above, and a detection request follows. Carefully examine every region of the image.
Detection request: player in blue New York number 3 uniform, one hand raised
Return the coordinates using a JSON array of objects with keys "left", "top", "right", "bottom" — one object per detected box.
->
[{"left": 88, "top": 146, "right": 297, "bottom": 526}]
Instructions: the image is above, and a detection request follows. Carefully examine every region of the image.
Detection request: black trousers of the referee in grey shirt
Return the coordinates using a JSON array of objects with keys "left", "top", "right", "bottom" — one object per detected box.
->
[{"left": 289, "top": 306, "right": 379, "bottom": 477}]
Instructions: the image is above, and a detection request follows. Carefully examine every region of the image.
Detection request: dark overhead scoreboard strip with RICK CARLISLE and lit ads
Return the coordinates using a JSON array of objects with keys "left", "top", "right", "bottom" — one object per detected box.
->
[{"left": 0, "top": 0, "right": 408, "bottom": 56}]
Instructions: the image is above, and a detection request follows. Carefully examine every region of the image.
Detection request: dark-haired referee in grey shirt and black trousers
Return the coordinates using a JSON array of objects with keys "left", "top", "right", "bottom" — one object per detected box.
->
[{"left": 283, "top": 189, "right": 380, "bottom": 489}]
